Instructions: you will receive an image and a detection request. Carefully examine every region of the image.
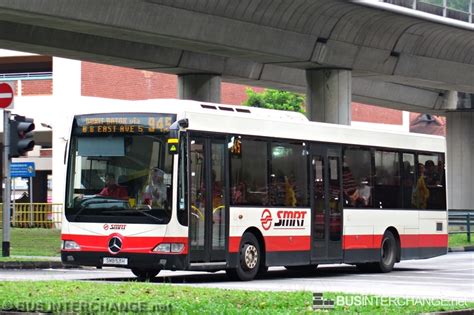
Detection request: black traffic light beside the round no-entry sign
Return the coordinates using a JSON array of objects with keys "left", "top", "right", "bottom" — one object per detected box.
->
[{"left": 10, "top": 115, "right": 35, "bottom": 157}]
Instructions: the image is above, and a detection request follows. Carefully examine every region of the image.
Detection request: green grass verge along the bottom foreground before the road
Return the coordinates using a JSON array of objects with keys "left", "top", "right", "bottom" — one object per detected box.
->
[{"left": 0, "top": 281, "right": 474, "bottom": 314}]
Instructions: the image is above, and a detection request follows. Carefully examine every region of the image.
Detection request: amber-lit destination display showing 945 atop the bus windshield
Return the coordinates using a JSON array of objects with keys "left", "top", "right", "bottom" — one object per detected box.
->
[{"left": 73, "top": 114, "right": 176, "bottom": 136}]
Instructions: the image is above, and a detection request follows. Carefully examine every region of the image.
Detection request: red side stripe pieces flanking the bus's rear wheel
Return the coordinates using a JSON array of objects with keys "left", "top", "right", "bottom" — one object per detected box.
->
[{"left": 343, "top": 234, "right": 448, "bottom": 249}]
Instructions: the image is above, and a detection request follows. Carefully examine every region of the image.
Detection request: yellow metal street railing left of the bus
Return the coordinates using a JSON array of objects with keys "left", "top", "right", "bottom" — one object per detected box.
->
[{"left": 0, "top": 203, "right": 63, "bottom": 229}]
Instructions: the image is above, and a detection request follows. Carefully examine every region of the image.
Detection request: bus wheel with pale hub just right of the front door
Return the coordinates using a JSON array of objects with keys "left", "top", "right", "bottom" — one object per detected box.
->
[{"left": 226, "top": 233, "right": 262, "bottom": 281}]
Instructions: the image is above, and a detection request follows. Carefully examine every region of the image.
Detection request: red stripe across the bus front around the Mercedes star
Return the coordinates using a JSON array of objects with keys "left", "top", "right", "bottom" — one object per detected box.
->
[{"left": 61, "top": 233, "right": 188, "bottom": 254}]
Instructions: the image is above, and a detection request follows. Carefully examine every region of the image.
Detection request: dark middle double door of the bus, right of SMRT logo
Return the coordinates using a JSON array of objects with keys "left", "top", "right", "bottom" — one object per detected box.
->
[{"left": 311, "top": 145, "right": 343, "bottom": 264}]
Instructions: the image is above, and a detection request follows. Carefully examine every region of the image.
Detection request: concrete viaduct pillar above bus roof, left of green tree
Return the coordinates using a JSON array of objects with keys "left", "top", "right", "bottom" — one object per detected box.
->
[{"left": 178, "top": 73, "right": 222, "bottom": 103}]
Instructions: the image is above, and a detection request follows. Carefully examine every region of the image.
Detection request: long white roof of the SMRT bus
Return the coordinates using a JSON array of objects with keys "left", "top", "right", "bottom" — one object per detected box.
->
[{"left": 73, "top": 99, "right": 446, "bottom": 152}]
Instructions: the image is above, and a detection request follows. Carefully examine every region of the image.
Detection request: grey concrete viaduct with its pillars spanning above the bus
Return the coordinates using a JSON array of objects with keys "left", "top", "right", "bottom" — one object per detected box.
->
[{"left": 0, "top": 0, "right": 474, "bottom": 209}]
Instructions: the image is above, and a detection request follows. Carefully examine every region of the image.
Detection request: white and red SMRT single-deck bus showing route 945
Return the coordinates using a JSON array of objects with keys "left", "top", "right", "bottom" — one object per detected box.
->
[{"left": 61, "top": 100, "right": 448, "bottom": 281}]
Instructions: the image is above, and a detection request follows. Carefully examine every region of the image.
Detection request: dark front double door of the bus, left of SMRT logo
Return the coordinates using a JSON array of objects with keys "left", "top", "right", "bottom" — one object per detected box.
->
[{"left": 189, "top": 137, "right": 227, "bottom": 263}]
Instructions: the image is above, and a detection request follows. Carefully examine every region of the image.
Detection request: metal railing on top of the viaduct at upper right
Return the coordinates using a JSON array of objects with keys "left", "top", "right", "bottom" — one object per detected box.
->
[{"left": 378, "top": 0, "right": 474, "bottom": 23}]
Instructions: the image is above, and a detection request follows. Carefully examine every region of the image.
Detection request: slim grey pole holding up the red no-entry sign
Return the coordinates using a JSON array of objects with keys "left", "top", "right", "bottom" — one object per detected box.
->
[{"left": 2, "top": 110, "right": 11, "bottom": 257}]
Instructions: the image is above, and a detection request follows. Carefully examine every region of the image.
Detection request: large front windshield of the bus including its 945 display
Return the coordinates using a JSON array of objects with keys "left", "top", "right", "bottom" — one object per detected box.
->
[{"left": 65, "top": 114, "right": 174, "bottom": 224}]
